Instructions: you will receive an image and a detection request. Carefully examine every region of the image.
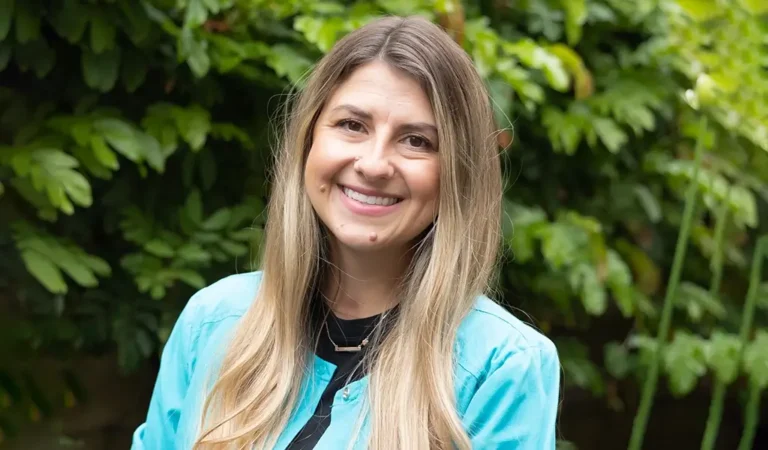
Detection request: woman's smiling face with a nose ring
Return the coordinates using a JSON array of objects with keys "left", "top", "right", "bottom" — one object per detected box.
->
[{"left": 304, "top": 61, "right": 440, "bottom": 251}]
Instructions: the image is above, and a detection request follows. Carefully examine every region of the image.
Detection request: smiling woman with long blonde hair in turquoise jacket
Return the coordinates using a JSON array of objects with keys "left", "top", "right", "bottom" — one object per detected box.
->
[{"left": 133, "top": 14, "right": 560, "bottom": 450}]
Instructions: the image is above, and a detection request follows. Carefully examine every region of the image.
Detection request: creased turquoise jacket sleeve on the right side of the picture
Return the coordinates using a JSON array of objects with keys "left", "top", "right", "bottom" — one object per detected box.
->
[{"left": 463, "top": 341, "right": 560, "bottom": 450}]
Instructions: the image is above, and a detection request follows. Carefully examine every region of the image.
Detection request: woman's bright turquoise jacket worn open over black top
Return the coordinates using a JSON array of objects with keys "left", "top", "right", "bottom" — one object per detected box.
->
[{"left": 131, "top": 272, "right": 560, "bottom": 450}]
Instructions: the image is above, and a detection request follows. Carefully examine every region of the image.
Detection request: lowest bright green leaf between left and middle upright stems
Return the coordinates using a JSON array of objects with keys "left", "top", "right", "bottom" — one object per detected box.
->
[{"left": 664, "top": 331, "right": 707, "bottom": 396}]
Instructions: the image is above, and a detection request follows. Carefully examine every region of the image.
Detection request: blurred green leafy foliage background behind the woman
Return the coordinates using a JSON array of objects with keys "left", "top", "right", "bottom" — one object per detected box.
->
[{"left": 0, "top": 0, "right": 768, "bottom": 450}]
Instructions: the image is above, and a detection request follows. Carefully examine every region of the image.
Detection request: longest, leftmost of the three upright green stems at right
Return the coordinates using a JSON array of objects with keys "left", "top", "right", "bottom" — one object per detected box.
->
[{"left": 629, "top": 116, "right": 707, "bottom": 450}]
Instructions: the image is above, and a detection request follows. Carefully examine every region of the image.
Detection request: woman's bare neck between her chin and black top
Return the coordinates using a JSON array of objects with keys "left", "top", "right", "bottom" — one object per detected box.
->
[{"left": 323, "top": 243, "right": 408, "bottom": 319}]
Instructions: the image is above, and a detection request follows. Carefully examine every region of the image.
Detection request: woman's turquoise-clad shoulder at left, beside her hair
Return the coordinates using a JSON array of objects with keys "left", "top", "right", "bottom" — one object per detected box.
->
[{"left": 182, "top": 271, "right": 261, "bottom": 328}]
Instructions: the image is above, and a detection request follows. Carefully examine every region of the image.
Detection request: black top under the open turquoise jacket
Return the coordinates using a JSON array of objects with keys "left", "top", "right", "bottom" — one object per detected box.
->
[{"left": 286, "top": 301, "right": 394, "bottom": 450}]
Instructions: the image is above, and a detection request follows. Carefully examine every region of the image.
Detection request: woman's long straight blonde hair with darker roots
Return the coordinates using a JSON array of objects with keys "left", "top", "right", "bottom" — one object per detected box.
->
[{"left": 194, "top": 17, "right": 502, "bottom": 450}]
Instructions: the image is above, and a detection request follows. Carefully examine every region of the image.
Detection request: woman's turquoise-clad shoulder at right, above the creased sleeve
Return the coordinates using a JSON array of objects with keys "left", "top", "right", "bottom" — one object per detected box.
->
[{"left": 457, "top": 296, "right": 559, "bottom": 380}]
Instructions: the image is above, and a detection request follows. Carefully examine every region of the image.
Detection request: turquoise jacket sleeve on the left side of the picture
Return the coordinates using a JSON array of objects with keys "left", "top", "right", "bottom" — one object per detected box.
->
[{"left": 131, "top": 301, "right": 194, "bottom": 450}]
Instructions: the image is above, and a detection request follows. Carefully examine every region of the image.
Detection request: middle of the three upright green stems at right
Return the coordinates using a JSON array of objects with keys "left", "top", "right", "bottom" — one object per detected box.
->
[{"left": 701, "top": 186, "right": 731, "bottom": 450}]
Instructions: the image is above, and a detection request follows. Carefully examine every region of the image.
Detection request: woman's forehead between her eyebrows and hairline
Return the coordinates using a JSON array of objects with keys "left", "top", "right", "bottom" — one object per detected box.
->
[{"left": 320, "top": 61, "right": 435, "bottom": 124}]
